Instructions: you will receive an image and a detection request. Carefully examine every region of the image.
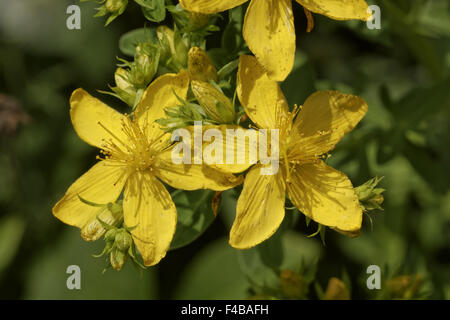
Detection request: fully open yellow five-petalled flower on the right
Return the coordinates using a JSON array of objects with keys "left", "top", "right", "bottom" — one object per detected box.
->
[{"left": 230, "top": 56, "right": 367, "bottom": 249}]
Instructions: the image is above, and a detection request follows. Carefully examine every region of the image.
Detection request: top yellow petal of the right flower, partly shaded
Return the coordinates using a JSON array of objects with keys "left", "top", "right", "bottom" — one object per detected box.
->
[{"left": 237, "top": 56, "right": 291, "bottom": 131}]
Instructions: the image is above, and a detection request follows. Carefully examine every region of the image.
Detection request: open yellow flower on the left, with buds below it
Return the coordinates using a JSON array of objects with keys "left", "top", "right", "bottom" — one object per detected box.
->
[{"left": 53, "top": 71, "right": 241, "bottom": 266}]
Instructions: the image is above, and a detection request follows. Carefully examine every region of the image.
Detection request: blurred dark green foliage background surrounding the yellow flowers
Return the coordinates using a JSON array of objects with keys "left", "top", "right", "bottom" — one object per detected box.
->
[{"left": 0, "top": 0, "right": 450, "bottom": 299}]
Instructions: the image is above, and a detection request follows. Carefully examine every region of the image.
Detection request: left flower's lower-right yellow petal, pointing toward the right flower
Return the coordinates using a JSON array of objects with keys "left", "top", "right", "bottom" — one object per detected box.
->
[{"left": 154, "top": 145, "right": 242, "bottom": 191}]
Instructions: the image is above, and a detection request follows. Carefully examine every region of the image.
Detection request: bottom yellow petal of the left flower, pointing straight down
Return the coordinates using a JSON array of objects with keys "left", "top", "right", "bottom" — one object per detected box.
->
[{"left": 123, "top": 173, "right": 177, "bottom": 266}]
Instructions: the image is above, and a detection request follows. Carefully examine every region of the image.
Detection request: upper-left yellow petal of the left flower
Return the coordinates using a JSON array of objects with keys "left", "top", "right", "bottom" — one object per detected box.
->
[{"left": 70, "top": 89, "right": 127, "bottom": 148}]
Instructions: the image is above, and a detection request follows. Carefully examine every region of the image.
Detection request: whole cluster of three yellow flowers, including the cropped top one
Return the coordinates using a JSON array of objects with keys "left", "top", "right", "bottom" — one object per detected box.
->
[{"left": 53, "top": 0, "right": 369, "bottom": 266}]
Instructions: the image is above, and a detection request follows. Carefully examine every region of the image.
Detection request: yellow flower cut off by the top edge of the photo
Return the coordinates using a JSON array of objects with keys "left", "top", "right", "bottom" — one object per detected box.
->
[{"left": 180, "top": 0, "right": 370, "bottom": 81}]
